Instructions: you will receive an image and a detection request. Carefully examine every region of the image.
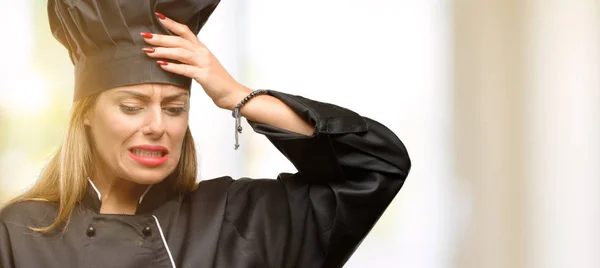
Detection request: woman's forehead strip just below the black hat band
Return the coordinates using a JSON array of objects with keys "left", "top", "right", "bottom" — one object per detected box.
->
[{"left": 104, "top": 83, "right": 189, "bottom": 98}]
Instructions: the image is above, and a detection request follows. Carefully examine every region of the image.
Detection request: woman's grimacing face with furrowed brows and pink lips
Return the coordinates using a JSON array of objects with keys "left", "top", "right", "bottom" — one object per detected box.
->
[{"left": 85, "top": 84, "right": 189, "bottom": 184}]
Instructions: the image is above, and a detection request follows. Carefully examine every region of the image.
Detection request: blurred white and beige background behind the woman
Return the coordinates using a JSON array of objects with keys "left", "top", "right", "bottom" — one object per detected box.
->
[{"left": 0, "top": 0, "right": 600, "bottom": 268}]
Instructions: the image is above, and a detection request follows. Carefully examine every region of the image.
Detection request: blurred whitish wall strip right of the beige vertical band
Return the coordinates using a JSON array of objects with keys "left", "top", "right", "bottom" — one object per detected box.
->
[{"left": 526, "top": 0, "right": 600, "bottom": 268}]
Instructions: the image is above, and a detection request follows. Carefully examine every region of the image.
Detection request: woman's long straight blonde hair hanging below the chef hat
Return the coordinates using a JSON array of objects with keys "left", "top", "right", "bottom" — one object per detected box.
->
[{"left": 10, "top": 94, "right": 197, "bottom": 233}]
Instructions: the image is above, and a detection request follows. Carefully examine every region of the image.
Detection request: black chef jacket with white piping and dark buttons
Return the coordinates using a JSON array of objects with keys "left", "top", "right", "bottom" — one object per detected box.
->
[{"left": 0, "top": 91, "right": 411, "bottom": 268}]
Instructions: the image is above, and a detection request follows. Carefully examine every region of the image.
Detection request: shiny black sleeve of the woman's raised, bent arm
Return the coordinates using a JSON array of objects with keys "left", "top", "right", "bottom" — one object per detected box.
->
[{"left": 227, "top": 91, "right": 411, "bottom": 267}]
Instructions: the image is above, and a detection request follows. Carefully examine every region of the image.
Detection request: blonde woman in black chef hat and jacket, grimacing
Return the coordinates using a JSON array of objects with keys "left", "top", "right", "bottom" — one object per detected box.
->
[{"left": 0, "top": 0, "right": 410, "bottom": 268}]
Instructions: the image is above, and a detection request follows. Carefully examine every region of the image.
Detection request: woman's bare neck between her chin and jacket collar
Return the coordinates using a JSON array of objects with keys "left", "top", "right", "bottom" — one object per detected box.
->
[{"left": 90, "top": 172, "right": 149, "bottom": 215}]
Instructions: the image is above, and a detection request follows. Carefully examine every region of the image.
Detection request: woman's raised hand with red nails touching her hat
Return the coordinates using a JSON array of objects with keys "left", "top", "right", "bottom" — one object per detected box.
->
[{"left": 141, "top": 14, "right": 252, "bottom": 110}]
